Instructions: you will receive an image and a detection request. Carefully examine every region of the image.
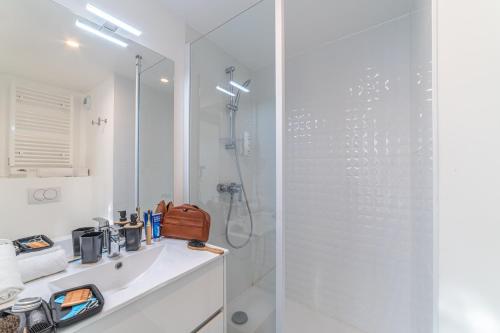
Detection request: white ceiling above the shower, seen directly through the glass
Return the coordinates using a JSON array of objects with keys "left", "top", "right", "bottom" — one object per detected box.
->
[{"left": 162, "top": 0, "right": 412, "bottom": 69}]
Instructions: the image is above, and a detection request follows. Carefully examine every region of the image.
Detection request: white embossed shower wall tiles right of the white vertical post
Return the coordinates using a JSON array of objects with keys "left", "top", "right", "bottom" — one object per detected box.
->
[{"left": 284, "top": 16, "right": 432, "bottom": 333}]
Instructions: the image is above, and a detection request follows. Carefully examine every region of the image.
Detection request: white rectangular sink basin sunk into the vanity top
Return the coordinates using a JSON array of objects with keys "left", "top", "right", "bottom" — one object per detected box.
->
[{"left": 49, "top": 246, "right": 164, "bottom": 295}]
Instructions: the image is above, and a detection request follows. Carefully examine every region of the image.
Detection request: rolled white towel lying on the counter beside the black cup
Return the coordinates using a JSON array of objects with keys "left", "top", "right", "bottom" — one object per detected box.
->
[{"left": 17, "top": 246, "right": 68, "bottom": 282}]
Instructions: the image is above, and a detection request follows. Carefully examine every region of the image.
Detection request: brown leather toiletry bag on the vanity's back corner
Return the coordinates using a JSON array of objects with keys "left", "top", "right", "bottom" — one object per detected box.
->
[{"left": 156, "top": 201, "right": 210, "bottom": 242}]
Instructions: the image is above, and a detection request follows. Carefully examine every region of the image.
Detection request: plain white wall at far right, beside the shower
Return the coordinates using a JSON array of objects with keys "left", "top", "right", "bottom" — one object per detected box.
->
[{"left": 436, "top": 0, "right": 500, "bottom": 333}]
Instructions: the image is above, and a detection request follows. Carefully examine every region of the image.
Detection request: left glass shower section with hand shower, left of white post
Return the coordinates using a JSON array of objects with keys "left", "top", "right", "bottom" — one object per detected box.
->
[{"left": 189, "top": 0, "right": 276, "bottom": 333}]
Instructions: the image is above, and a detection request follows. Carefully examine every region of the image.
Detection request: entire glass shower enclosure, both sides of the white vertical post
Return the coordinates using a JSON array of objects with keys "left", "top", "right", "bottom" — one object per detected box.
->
[{"left": 189, "top": 0, "right": 436, "bottom": 333}]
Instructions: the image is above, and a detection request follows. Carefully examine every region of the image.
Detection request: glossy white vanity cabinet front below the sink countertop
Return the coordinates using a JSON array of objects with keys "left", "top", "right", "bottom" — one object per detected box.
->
[{"left": 75, "top": 256, "right": 224, "bottom": 333}]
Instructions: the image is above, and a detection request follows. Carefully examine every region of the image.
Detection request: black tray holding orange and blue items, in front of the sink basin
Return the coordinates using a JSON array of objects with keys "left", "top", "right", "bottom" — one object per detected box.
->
[{"left": 50, "top": 284, "right": 104, "bottom": 327}]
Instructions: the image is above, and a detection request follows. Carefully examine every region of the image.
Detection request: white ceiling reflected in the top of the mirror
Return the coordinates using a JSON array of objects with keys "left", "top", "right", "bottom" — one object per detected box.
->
[{"left": 0, "top": 0, "right": 174, "bottom": 92}]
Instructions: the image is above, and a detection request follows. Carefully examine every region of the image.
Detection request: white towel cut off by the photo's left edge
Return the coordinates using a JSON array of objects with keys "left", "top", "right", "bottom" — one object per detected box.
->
[{"left": 0, "top": 239, "right": 24, "bottom": 304}]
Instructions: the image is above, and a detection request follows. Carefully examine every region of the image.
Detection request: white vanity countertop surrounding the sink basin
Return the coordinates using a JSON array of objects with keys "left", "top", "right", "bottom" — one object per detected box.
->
[{"left": 2, "top": 239, "right": 227, "bottom": 333}]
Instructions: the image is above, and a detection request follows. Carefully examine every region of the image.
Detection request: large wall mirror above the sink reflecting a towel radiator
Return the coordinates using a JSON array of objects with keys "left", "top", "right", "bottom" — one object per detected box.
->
[{"left": 0, "top": 0, "right": 174, "bottom": 239}]
